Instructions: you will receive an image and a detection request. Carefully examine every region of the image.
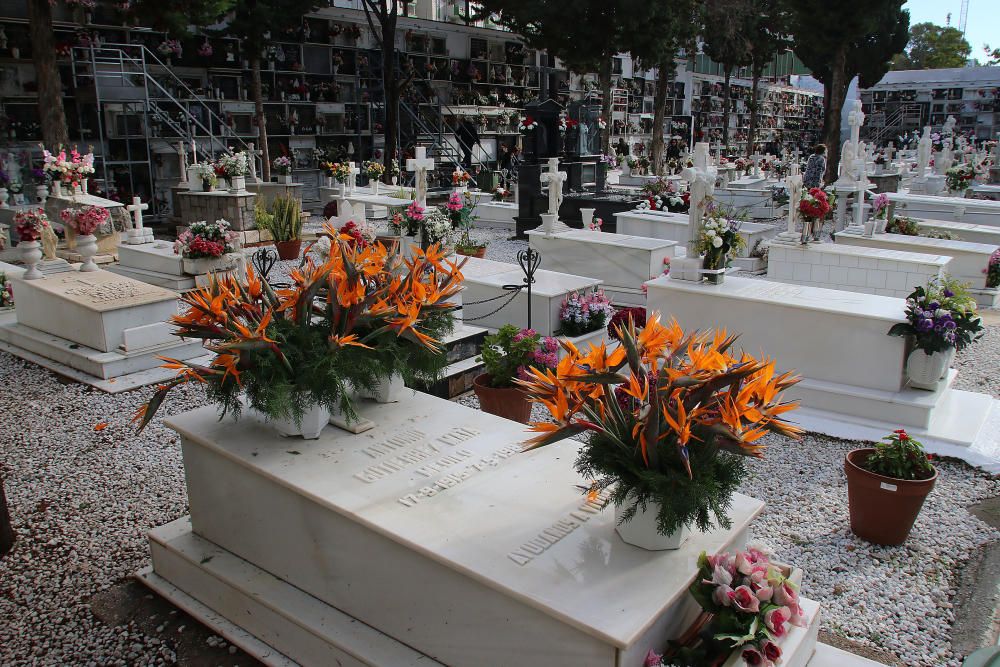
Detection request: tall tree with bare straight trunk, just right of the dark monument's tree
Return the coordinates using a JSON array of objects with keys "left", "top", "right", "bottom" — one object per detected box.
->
[{"left": 629, "top": 0, "right": 703, "bottom": 176}]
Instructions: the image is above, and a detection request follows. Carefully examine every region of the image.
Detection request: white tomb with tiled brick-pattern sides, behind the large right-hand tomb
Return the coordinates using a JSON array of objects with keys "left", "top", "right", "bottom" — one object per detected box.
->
[{"left": 767, "top": 241, "right": 951, "bottom": 298}]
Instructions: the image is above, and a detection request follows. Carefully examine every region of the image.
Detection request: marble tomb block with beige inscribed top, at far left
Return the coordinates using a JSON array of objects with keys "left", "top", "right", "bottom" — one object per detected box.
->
[{"left": 12, "top": 271, "right": 177, "bottom": 352}]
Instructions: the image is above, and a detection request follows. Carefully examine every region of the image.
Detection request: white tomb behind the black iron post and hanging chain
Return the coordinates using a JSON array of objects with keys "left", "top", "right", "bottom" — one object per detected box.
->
[{"left": 462, "top": 257, "right": 602, "bottom": 336}]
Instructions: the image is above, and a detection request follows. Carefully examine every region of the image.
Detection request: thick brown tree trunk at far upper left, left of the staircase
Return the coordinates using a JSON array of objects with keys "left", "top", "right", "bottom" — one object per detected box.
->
[{"left": 28, "top": 0, "right": 69, "bottom": 151}]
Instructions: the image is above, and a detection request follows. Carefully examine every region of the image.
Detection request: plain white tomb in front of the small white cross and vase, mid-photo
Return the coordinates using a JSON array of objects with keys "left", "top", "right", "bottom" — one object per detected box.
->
[{"left": 528, "top": 229, "right": 678, "bottom": 306}]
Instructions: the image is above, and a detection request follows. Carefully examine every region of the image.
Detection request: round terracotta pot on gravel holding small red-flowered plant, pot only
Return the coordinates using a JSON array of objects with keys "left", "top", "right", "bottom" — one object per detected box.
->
[{"left": 844, "top": 448, "right": 937, "bottom": 546}]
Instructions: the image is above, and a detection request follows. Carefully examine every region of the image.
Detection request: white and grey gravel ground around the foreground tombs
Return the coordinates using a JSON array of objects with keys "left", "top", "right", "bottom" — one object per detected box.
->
[{"left": 0, "top": 230, "right": 1000, "bottom": 665}]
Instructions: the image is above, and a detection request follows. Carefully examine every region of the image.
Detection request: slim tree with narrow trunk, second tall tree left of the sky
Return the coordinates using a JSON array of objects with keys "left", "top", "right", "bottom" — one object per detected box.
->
[{"left": 702, "top": 0, "right": 756, "bottom": 153}]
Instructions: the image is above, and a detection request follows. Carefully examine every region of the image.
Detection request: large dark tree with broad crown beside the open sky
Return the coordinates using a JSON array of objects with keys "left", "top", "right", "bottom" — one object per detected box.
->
[{"left": 785, "top": 0, "right": 910, "bottom": 182}]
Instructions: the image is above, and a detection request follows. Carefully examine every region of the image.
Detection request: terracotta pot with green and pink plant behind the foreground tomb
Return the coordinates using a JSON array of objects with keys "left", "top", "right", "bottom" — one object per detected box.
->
[{"left": 472, "top": 324, "right": 558, "bottom": 424}]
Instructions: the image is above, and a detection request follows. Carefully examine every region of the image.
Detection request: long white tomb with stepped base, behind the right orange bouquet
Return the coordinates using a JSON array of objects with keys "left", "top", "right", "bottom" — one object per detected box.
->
[{"left": 647, "top": 276, "right": 1000, "bottom": 470}]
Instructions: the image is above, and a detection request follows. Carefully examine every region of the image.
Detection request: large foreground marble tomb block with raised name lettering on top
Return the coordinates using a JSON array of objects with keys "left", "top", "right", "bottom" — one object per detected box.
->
[{"left": 162, "top": 394, "right": 763, "bottom": 667}]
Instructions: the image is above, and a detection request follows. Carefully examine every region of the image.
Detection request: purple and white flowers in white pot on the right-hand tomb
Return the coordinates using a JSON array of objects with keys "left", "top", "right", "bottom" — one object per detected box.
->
[{"left": 889, "top": 278, "right": 983, "bottom": 391}]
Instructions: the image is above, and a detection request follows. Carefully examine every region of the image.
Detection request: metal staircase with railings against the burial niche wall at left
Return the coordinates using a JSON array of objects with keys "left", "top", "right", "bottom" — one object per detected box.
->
[{"left": 71, "top": 44, "right": 261, "bottom": 217}]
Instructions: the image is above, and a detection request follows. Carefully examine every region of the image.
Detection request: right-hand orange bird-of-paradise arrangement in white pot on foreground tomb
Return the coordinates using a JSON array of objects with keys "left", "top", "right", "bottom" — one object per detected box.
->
[{"left": 518, "top": 313, "right": 801, "bottom": 549}]
